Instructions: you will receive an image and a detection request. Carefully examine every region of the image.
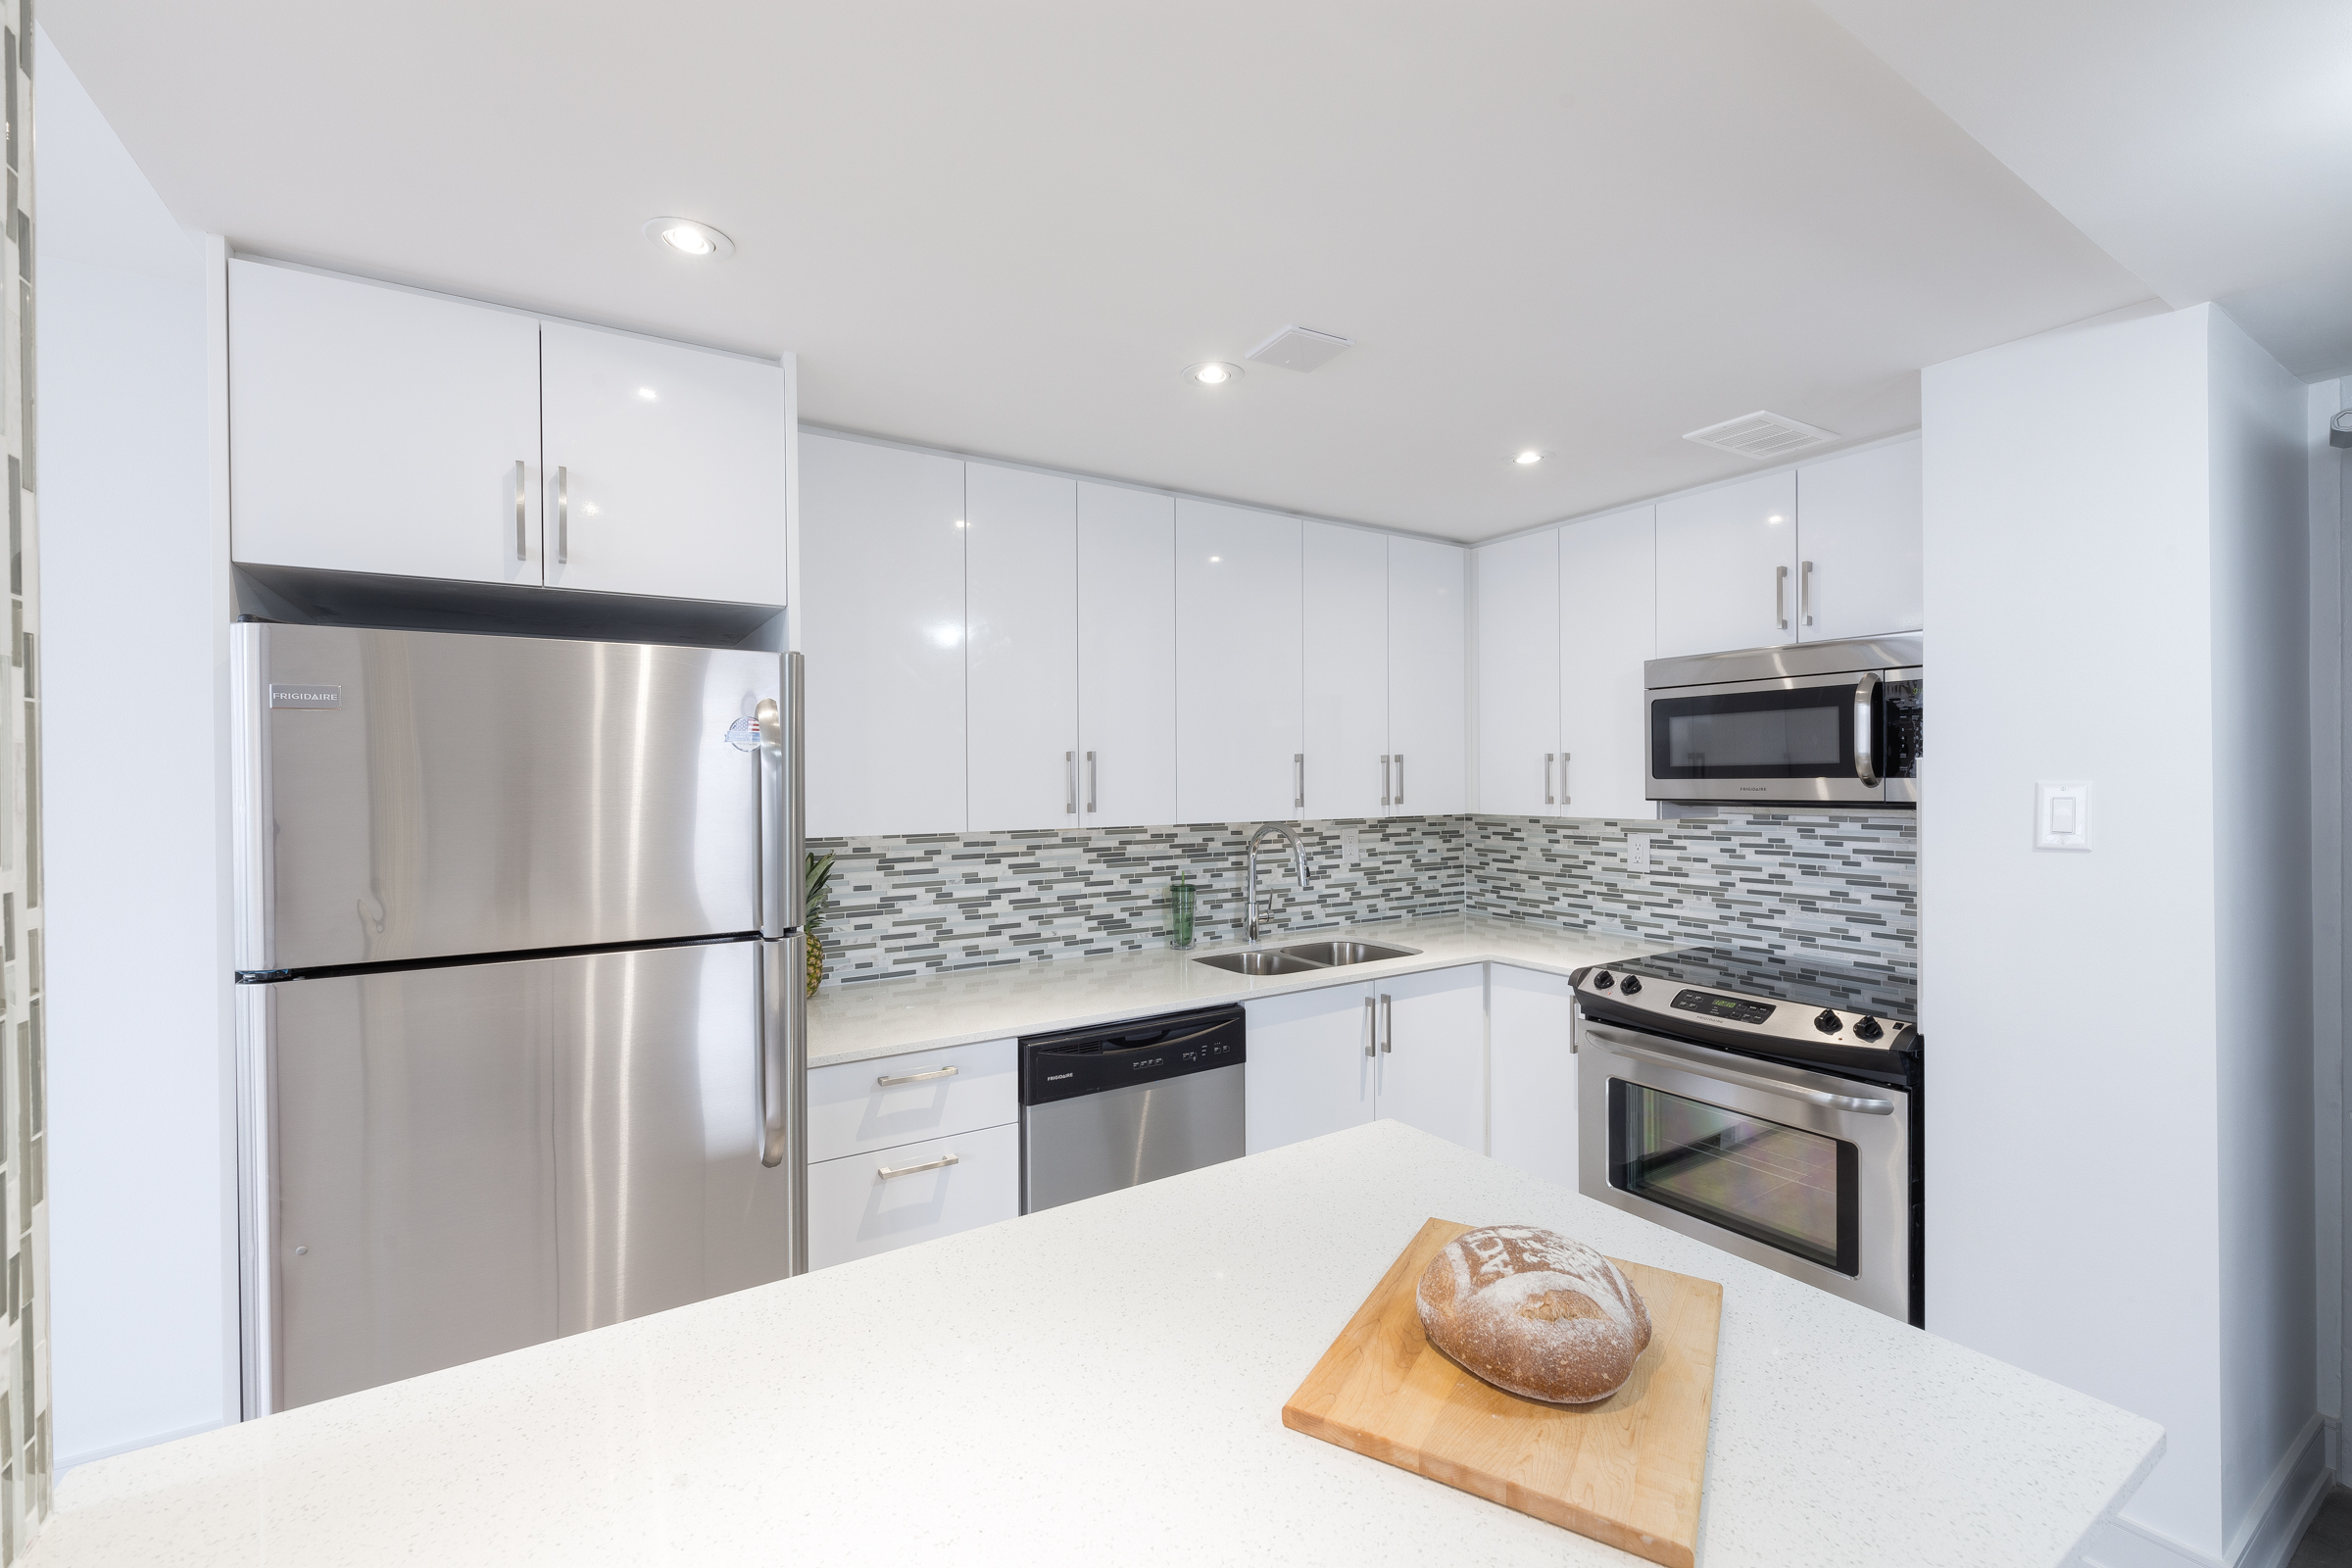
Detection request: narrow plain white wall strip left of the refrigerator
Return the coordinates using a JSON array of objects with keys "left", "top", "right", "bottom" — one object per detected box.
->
[{"left": 35, "top": 35, "right": 237, "bottom": 1469}]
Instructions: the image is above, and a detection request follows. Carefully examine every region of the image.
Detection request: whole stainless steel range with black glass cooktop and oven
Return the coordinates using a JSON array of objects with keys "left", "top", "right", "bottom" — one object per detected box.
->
[{"left": 1574, "top": 948, "right": 1924, "bottom": 1326}]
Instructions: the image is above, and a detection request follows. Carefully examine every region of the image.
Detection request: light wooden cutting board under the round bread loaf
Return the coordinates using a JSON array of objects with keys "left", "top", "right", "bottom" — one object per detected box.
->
[{"left": 1282, "top": 1220, "right": 1724, "bottom": 1568}]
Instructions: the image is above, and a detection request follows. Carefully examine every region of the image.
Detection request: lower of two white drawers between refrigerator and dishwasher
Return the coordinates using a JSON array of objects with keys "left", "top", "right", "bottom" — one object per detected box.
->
[{"left": 809, "top": 1121, "right": 1021, "bottom": 1269}]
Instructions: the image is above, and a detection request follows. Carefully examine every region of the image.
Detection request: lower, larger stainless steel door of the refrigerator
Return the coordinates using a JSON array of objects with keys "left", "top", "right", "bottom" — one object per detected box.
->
[{"left": 259, "top": 941, "right": 800, "bottom": 1410}]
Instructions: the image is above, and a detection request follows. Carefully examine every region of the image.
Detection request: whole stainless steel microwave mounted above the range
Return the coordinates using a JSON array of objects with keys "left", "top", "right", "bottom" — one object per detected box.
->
[{"left": 1644, "top": 637, "right": 1922, "bottom": 807}]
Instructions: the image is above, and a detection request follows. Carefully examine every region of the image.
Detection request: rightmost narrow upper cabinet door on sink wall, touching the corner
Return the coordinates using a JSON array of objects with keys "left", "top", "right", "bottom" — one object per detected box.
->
[{"left": 1383, "top": 536, "right": 1470, "bottom": 815}]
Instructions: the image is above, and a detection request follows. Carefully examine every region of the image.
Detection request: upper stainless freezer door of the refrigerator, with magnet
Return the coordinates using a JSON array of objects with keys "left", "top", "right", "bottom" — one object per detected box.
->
[{"left": 235, "top": 623, "right": 781, "bottom": 971}]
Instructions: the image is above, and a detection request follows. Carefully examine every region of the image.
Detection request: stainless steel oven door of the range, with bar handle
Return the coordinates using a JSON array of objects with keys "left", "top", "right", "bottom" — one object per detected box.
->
[{"left": 1576, "top": 1022, "right": 1910, "bottom": 1321}]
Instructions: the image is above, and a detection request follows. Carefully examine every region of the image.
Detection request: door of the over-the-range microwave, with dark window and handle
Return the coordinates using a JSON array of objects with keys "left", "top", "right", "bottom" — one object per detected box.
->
[{"left": 1648, "top": 672, "right": 1912, "bottom": 802}]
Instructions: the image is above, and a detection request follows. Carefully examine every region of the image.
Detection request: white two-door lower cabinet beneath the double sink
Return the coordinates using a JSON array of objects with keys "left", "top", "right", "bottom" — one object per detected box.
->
[{"left": 1242, "top": 964, "right": 1487, "bottom": 1154}]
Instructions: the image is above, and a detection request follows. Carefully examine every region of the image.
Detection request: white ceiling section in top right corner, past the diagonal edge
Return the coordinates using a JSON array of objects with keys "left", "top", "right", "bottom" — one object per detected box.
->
[{"left": 1821, "top": 0, "right": 2352, "bottom": 378}]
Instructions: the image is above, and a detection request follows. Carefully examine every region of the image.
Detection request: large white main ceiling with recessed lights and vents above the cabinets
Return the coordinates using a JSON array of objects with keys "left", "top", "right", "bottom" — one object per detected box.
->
[{"left": 42, "top": 0, "right": 2150, "bottom": 538}]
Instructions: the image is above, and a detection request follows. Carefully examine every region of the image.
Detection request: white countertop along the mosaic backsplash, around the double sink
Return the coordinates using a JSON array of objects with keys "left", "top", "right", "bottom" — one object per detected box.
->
[{"left": 809, "top": 914, "right": 1689, "bottom": 1067}]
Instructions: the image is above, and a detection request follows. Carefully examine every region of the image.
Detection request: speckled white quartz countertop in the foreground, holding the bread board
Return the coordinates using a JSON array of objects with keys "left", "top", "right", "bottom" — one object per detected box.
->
[{"left": 41, "top": 1121, "right": 2164, "bottom": 1568}]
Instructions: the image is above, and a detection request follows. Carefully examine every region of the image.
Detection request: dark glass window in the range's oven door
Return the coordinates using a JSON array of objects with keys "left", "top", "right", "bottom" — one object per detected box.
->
[{"left": 1609, "top": 1079, "right": 1860, "bottom": 1274}]
